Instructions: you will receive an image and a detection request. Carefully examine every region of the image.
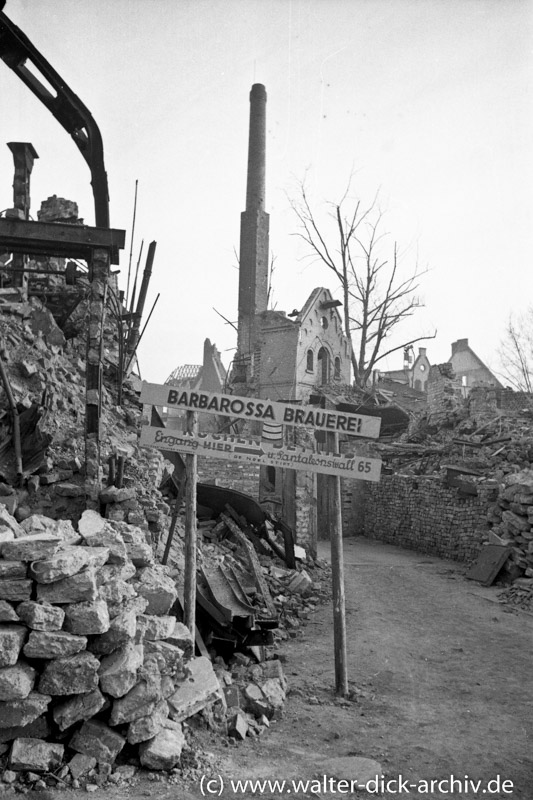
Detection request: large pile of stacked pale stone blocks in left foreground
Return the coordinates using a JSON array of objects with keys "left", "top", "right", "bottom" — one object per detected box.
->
[{"left": 0, "top": 506, "right": 220, "bottom": 786}]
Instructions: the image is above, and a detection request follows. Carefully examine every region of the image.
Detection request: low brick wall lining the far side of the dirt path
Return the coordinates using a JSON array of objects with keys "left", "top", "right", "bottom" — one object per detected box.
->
[{"left": 344, "top": 475, "right": 495, "bottom": 561}]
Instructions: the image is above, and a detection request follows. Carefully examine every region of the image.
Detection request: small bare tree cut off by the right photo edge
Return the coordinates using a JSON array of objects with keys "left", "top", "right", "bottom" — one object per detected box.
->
[{"left": 498, "top": 306, "right": 533, "bottom": 393}]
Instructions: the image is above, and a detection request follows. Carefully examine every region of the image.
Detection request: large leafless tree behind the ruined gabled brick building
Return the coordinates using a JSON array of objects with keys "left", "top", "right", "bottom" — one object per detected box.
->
[{"left": 290, "top": 179, "right": 436, "bottom": 387}]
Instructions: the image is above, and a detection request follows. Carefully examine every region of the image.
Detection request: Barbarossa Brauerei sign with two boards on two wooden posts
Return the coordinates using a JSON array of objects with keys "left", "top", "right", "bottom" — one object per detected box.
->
[{"left": 140, "top": 382, "right": 381, "bottom": 697}]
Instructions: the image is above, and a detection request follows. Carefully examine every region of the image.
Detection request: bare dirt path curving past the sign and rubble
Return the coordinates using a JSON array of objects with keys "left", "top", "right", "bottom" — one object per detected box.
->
[{"left": 38, "top": 538, "right": 533, "bottom": 800}]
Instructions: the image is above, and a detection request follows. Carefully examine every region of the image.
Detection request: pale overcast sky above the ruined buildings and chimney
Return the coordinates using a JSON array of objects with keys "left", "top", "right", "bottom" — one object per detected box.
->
[{"left": 0, "top": 0, "right": 533, "bottom": 382}]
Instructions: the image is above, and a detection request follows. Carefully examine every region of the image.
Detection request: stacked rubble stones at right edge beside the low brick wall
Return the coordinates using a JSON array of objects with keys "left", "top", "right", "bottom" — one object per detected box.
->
[{"left": 487, "top": 469, "right": 533, "bottom": 578}]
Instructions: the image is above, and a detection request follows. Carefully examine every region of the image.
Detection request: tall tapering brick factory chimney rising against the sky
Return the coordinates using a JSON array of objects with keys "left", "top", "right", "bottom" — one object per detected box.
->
[{"left": 237, "top": 83, "right": 269, "bottom": 379}]
